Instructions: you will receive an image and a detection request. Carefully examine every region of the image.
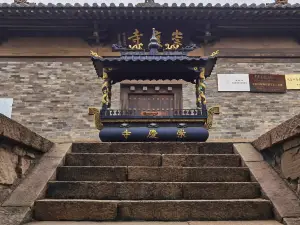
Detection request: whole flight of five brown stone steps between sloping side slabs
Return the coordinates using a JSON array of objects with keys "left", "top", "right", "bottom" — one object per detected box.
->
[{"left": 34, "top": 143, "right": 274, "bottom": 221}]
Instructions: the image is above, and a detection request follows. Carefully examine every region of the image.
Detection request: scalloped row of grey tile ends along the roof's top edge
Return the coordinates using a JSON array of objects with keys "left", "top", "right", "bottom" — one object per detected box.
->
[{"left": 0, "top": 3, "right": 300, "bottom": 9}]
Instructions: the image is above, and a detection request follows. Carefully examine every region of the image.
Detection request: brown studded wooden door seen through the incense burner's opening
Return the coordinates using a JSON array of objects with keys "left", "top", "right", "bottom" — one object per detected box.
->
[{"left": 128, "top": 94, "right": 174, "bottom": 116}]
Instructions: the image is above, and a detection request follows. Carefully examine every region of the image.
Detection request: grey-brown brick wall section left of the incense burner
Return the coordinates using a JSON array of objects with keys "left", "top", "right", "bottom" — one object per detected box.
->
[{"left": 0, "top": 58, "right": 102, "bottom": 140}]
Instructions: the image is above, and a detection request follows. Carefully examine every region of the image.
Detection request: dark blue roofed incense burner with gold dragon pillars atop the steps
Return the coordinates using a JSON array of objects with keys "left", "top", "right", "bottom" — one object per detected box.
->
[{"left": 90, "top": 28, "right": 217, "bottom": 142}]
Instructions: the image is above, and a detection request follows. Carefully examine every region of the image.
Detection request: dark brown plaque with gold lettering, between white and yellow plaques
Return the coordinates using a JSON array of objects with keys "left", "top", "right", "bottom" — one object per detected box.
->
[{"left": 249, "top": 74, "right": 286, "bottom": 93}]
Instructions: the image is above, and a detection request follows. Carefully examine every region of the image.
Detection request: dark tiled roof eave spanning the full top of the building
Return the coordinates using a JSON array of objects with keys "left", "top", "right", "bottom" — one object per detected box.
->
[{"left": 0, "top": 1, "right": 300, "bottom": 22}]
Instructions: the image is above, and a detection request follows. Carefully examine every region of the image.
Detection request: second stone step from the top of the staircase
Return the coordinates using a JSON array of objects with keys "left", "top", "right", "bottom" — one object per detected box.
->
[{"left": 65, "top": 153, "right": 240, "bottom": 167}]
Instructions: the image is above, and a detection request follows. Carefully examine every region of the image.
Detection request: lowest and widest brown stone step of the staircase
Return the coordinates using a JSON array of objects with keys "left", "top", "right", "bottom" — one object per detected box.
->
[{"left": 34, "top": 199, "right": 273, "bottom": 221}]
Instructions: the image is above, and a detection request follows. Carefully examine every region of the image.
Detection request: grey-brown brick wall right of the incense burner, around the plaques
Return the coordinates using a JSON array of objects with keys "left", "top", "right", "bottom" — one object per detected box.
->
[{"left": 183, "top": 59, "right": 300, "bottom": 140}]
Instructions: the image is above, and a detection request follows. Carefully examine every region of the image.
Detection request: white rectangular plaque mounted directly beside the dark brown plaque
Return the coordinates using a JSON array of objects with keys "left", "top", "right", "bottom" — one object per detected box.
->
[{"left": 218, "top": 74, "right": 250, "bottom": 91}]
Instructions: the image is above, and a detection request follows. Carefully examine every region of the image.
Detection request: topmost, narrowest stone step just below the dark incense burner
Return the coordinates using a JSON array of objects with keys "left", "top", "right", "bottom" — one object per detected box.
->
[{"left": 72, "top": 142, "right": 233, "bottom": 154}]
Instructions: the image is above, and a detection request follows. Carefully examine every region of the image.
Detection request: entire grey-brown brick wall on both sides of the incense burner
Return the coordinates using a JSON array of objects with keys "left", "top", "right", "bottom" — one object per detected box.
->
[{"left": 0, "top": 58, "right": 300, "bottom": 140}]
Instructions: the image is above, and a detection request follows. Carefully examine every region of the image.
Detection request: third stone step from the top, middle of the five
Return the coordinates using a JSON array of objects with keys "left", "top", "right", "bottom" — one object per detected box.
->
[{"left": 57, "top": 166, "right": 250, "bottom": 182}]
